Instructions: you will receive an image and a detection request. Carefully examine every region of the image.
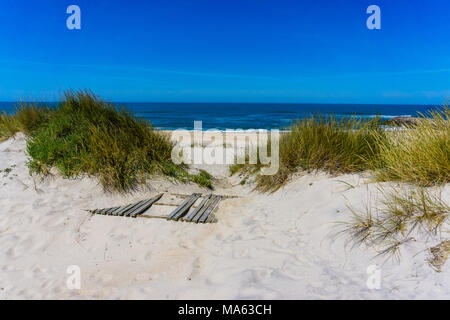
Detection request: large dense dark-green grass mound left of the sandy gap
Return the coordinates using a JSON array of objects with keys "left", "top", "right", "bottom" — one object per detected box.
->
[{"left": 0, "top": 90, "right": 212, "bottom": 192}]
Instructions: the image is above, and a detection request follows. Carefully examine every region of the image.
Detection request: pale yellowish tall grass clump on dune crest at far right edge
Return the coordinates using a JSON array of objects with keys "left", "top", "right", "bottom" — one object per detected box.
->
[{"left": 375, "top": 106, "right": 450, "bottom": 186}]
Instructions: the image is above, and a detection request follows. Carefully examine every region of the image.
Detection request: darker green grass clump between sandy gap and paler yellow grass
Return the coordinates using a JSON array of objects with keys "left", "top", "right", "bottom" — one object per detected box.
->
[{"left": 246, "top": 115, "right": 385, "bottom": 191}]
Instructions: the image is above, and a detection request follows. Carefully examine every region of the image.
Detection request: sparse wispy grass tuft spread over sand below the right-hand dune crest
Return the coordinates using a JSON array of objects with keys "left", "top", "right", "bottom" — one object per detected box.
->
[{"left": 339, "top": 186, "right": 450, "bottom": 258}]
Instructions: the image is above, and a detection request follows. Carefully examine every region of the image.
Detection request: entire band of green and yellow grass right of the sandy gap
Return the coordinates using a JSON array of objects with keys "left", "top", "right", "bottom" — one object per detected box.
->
[{"left": 230, "top": 106, "right": 450, "bottom": 191}]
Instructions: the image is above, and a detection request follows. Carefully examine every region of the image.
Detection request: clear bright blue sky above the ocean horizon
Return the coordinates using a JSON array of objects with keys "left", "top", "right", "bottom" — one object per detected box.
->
[{"left": 0, "top": 0, "right": 450, "bottom": 104}]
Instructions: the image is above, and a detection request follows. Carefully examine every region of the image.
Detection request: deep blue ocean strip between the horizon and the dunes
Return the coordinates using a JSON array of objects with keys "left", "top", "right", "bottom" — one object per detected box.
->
[{"left": 0, "top": 102, "right": 437, "bottom": 130}]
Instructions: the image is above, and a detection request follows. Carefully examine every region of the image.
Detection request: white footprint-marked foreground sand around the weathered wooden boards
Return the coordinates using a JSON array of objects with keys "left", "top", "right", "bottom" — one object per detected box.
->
[{"left": 0, "top": 135, "right": 450, "bottom": 299}]
